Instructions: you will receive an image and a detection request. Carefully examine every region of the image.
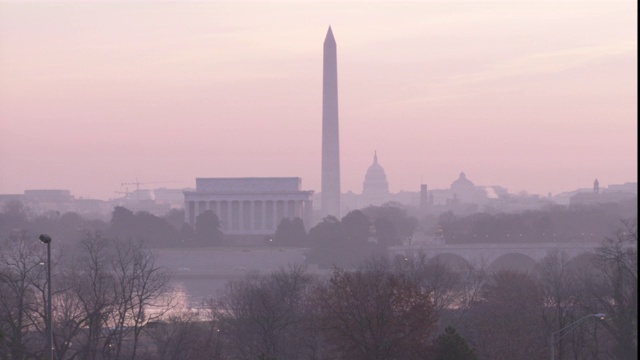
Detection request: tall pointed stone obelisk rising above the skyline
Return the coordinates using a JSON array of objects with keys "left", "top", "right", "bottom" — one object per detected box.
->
[{"left": 320, "top": 26, "right": 340, "bottom": 219}]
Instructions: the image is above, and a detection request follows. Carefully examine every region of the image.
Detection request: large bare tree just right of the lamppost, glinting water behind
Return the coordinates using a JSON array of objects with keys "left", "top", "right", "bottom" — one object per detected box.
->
[{"left": 55, "top": 233, "right": 171, "bottom": 359}]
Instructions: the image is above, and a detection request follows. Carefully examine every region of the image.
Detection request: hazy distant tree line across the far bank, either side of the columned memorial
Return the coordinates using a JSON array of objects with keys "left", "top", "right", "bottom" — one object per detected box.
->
[{"left": 0, "top": 199, "right": 637, "bottom": 250}]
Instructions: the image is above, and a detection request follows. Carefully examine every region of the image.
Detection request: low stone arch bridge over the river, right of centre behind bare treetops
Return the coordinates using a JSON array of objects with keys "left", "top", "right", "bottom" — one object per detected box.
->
[{"left": 389, "top": 242, "right": 602, "bottom": 272}]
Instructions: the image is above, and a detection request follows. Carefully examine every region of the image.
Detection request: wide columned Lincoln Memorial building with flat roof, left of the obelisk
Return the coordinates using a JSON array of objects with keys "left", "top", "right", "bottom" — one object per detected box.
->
[{"left": 184, "top": 177, "right": 313, "bottom": 235}]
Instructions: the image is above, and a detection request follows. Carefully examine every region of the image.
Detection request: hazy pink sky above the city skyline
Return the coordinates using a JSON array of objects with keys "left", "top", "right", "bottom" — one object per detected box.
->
[{"left": 0, "top": 0, "right": 638, "bottom": 199}]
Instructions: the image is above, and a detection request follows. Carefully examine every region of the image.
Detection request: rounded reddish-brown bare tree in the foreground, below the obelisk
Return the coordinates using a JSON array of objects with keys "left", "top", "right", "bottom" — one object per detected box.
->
[{"left": 314, "top": 260, "right": 436, "bottom": 360}]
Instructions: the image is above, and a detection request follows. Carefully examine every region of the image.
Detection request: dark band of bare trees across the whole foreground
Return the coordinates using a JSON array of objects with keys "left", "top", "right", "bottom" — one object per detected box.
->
[{"left": 0, "top": 219, "right": 638, "bottom": 360}]
